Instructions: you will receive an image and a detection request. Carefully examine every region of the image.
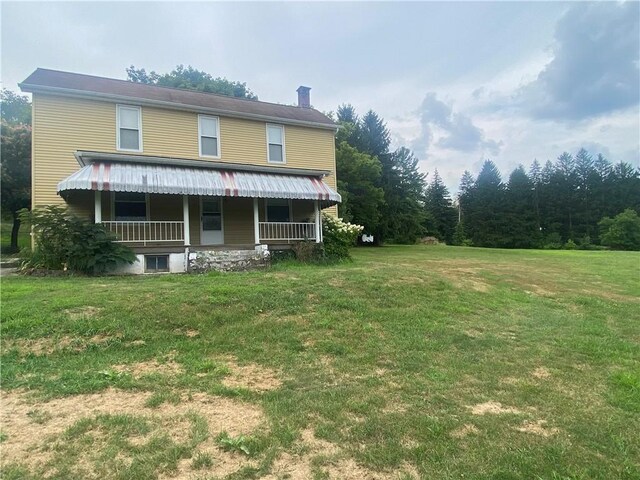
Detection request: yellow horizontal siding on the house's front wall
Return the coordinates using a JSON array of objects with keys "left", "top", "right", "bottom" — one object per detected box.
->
[{"left": 32, "top": 94, "right": 336, "bottom": 220}]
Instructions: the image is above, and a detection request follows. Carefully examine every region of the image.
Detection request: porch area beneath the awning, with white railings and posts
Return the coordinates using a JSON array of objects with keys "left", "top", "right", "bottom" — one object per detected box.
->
[{"left": 94, "top": 191, "right": 322, "bottom": 248}]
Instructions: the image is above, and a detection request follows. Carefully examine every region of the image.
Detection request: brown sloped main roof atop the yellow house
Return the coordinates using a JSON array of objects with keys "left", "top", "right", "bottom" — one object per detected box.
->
[{"left": 20, "top": 68, "right": 337, "bottom": 130}]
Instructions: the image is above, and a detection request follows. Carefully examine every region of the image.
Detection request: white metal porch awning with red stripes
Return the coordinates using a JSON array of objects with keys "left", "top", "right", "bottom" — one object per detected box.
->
[{"left": 58, "top": 162, "right": 341, "bottom": 206}]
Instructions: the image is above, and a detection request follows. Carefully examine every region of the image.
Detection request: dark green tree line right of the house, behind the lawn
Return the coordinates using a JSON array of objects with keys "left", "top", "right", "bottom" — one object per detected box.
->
[{"left": 336, "top": 105, "right": 640, "bottom": 248}]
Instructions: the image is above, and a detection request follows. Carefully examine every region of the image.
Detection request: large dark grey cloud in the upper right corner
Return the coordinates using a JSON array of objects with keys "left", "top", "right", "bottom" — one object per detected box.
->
[{"left": 516, "top": 1, "right": 640, "bottom": 120}]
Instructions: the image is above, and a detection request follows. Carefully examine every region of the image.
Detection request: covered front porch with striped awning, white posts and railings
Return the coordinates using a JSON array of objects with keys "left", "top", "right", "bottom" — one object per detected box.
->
[{"left": 58, "top": 153, "right": 340, "bottom": 250}]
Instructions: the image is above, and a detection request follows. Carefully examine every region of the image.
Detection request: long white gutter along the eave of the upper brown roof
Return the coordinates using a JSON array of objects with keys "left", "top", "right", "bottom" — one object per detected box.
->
[{"left": 18, "top": 83, "right": 339, "bottom": 132}]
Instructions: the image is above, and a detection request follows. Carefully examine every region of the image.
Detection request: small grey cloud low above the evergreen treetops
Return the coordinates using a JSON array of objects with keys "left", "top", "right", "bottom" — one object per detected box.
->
[{"left": 412, "top": 92, "right": 502, "bottom": 155}]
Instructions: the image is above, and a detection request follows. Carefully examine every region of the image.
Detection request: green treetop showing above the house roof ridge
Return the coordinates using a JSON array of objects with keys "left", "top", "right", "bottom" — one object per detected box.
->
[{"left": 126, "top": 65, "right": 258, "bottom": 100}]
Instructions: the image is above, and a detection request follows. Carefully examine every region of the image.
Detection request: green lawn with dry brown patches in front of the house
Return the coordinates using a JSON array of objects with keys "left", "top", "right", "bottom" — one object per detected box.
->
[{"left": 0, "top": 246, "right": 640, "bottom": 480}]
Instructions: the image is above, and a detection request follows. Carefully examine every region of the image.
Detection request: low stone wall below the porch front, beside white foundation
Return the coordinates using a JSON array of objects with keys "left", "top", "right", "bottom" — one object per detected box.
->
[{"left": 189, "top": 250, "right": 270, "bottom": 273}]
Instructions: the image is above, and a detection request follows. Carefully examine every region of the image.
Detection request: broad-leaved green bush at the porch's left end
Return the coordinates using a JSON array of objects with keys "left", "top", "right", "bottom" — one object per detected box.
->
[{"left": 21, "top": 206, "right": 136, "bottom": 274}]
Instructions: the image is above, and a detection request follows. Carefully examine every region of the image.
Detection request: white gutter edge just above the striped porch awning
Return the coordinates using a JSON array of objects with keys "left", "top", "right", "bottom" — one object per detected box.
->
[{"left": 73, "top": 150, "right": 331, "bottom": 178}]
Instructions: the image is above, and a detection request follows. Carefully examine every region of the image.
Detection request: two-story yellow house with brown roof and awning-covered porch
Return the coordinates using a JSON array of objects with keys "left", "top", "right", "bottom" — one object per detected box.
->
[{"left": 20, "top": 68, "right": 340, "bottom": 273}]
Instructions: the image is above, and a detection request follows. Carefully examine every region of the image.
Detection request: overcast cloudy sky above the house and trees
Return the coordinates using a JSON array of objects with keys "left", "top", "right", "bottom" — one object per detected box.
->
[{"left": 0, "top": 1, "right": 640, "bottom": 191}]
